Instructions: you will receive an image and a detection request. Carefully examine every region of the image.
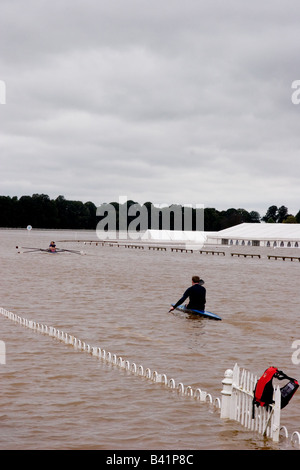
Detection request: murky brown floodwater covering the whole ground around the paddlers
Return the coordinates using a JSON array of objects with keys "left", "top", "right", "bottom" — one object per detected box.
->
[{"left": 0, "top": 230, "right": 300, "bottom": 450}]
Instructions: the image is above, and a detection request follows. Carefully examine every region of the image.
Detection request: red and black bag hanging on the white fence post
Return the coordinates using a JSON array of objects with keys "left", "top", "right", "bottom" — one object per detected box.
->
[{"left": 252, "top": 367, "right": 299, "bottom": 418}]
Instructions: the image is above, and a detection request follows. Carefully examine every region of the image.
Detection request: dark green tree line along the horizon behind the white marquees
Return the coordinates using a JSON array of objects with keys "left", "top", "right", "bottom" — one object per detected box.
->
[{"left": 0, "top": 194, "right": 300, "bottom": 232}]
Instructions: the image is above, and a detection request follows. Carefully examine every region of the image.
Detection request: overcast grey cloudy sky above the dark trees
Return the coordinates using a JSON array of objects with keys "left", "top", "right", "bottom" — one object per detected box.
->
[{"left": 0, "top": 0, "right": 300, "bottom": 215}]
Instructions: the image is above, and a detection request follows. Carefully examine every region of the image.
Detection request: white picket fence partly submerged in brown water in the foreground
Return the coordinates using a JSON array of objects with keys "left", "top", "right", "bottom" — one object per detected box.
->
[{"left": 0, "top": 307, "right": 300, "bottom": 446}]
